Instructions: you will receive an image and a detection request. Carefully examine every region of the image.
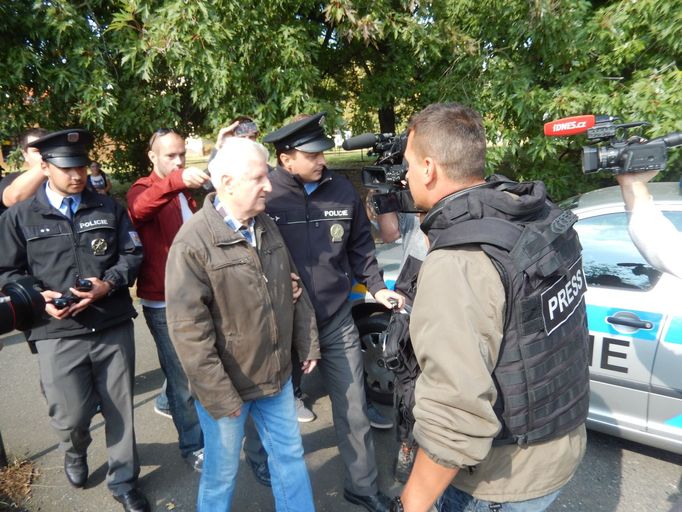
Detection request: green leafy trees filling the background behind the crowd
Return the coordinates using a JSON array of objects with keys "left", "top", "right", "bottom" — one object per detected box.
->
[{"left": 0, "top": 0, "right": 682, "bottom": 199}]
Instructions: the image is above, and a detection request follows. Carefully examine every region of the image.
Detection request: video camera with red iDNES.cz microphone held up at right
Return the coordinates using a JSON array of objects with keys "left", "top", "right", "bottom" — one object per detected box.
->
[{"left": 545, "top": 115, "right": 682, "bottom": 174}]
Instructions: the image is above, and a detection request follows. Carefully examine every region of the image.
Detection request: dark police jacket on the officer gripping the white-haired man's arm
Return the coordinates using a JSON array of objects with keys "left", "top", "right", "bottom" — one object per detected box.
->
[{"left": 266, "top": 166, "right": 386, "bottom": 323}]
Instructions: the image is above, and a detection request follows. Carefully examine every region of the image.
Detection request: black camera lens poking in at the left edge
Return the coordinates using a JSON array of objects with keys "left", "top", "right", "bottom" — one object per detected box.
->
[{"left": 0, "top": 277, "right": 45, "bottom": 334}]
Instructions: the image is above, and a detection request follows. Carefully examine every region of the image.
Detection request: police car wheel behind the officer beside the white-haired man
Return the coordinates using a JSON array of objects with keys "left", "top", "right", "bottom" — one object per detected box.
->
[{"left": 355, "top": 313, "right": 393, "bottom": 405}]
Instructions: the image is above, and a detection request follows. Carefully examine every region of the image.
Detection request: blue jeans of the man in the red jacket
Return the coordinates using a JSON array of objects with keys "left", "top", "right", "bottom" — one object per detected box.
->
[{"left": 142, "top": 306, "right": 199, "bottom": 457}]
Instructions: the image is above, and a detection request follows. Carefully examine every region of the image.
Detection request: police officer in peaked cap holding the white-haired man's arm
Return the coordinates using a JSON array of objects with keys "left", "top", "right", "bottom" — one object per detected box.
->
[{"left": 251, "top": 113, "right": 404, "bottom": 511}]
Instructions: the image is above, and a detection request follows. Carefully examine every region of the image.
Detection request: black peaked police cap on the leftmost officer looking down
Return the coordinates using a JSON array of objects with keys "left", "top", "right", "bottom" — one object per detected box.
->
[{"left": 27, "top": 128, "right": 92, "bottom": 169}]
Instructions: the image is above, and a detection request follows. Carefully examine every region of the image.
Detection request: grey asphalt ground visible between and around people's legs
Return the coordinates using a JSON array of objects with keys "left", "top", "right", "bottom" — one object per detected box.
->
[{"left": 0, "top": 308, "right": 682, "bottom": 512}]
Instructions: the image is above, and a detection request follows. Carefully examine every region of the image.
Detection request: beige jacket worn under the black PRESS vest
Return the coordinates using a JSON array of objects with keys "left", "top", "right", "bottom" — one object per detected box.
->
[{"left": 410, "top": 247, "right": 586, "bottom": 502}]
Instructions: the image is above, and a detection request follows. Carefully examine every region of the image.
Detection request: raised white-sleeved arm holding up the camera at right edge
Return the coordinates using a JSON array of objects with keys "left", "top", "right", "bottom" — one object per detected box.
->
[{"left": 616, "top": 171, "right": 682, "bottom": 278}]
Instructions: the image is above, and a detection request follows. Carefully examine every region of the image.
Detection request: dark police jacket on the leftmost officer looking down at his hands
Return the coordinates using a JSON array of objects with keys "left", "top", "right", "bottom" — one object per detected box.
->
[{"left": 0, "top": 187, "right": 142, "bottom": 341}]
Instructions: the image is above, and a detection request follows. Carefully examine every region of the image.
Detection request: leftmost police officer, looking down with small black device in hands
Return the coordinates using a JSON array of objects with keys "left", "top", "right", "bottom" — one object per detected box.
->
[{"left": 0, "top": 129, "right": 149, "bottom": 511}]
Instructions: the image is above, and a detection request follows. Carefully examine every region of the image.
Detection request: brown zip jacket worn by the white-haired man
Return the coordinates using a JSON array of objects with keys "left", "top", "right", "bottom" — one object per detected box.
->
[{"left": 165, "top": 194, "right": 320, "bottom": 419}]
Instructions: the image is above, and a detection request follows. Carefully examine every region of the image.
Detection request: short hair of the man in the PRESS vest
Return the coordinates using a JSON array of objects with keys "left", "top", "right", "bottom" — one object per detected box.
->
[{"left": 407, "top": 103, "right": 486, "bottom": 181}]
